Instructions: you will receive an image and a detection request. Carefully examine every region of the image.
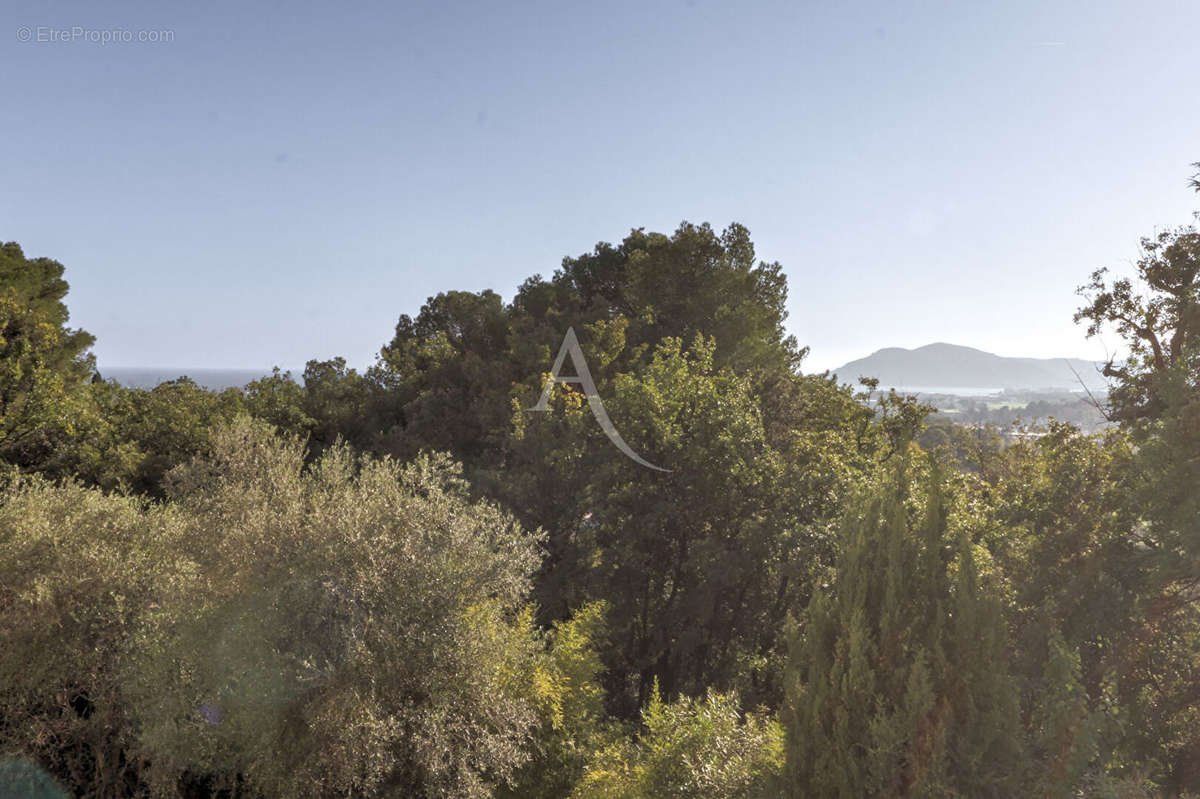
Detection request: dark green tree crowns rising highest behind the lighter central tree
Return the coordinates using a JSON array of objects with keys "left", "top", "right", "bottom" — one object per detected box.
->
[{"left": 371, "top": 222, "right": 804, "bottom": 471}]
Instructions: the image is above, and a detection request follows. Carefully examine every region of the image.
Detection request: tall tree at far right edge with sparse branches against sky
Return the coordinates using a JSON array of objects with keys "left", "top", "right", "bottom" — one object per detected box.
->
[{"left": 1076, "top": 173, "right": 1200, "bottom": 793}]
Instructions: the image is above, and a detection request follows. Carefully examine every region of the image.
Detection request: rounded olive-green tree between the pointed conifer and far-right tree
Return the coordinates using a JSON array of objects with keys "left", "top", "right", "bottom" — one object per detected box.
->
[{"left": 970, "top": 423, "right": 1132, "bottom": 657}]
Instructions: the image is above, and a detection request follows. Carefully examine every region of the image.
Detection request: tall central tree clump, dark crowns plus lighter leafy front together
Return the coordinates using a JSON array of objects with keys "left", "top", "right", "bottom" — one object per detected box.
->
[{"left": 362, "top": 223, "right": 897, "bottom": 717}]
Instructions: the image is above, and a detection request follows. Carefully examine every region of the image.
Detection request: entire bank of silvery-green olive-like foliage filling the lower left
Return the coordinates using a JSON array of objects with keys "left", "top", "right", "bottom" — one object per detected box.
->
[{"left": 0, "top": 420, "right": 547, "bottom": 797}]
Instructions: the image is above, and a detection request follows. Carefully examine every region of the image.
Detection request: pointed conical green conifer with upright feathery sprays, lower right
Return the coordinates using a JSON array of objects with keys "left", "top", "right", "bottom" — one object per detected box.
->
[{"left": 782, "top": 458, "right": 1022, "bottom": 799}]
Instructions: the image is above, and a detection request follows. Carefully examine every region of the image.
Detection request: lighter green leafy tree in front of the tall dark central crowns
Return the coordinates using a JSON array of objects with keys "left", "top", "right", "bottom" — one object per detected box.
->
[{"left": 497, "top": 338, "right": 883, "bottom": 716}]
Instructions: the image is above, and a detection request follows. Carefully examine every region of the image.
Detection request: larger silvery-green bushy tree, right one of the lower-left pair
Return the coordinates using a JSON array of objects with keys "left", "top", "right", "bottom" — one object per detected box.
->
[{"left": 137, "top": 421, "right": 538, "bottom": 797}]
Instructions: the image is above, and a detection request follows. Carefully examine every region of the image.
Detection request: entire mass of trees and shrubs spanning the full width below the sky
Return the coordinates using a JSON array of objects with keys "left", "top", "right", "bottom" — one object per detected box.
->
[{"left": 0, "top": 177, "right": 1200, "bottom": 799}]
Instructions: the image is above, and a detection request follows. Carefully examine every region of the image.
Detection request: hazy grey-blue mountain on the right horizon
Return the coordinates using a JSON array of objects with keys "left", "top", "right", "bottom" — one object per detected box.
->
[{"left": 833, "top": 343, "right": 1106, "bottom": 394}]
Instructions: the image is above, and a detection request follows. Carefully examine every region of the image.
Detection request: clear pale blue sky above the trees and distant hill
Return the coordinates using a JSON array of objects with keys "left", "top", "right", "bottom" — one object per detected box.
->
[{"left": 0, "top": 0, "right": 1200, "bottom": 371}]
